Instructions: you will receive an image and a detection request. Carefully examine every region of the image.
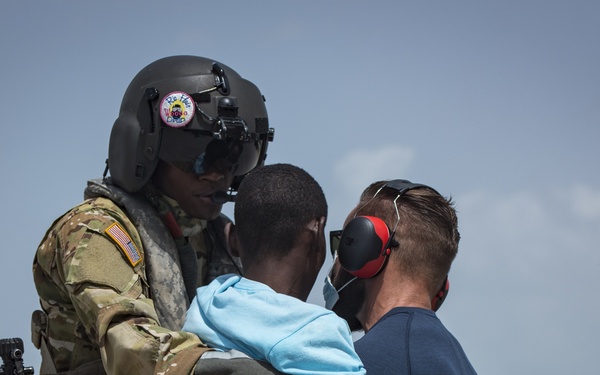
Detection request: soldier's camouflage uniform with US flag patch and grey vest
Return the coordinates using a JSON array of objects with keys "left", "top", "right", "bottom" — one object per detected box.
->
[{"left": 32, "top": 181, "right": 237, "bottom": 374}]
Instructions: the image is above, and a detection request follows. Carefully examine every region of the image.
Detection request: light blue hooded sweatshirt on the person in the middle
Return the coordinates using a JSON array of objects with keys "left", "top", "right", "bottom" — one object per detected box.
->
[{"left": 183, "top": 275, "right": 365, "bottom": 374}]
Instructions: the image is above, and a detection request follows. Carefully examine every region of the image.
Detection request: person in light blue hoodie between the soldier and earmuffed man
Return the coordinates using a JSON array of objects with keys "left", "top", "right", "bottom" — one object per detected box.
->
[{"left": 183, "top": 164, "right": 365, "bottom": 375}]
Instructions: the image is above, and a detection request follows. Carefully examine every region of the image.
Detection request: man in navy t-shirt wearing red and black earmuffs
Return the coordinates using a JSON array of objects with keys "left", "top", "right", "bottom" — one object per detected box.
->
[{"left": 323, "top": 180, "right": 476, "bottom": 375}]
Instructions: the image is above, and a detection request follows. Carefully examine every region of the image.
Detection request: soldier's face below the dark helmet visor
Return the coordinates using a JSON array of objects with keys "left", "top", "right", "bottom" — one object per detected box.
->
[{"left": 154, "top": 161, "right": 233, "bottom": 220}]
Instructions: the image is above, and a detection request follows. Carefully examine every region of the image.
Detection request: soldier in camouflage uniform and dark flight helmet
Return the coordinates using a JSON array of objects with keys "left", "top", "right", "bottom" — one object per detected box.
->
[{"left": 32, "top": 56, "right": 273, "bottom": 374}]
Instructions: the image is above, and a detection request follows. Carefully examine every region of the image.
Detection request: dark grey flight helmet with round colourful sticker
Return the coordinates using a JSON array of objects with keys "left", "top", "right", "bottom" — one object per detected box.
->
[{"left": 107, "top": 56, "right": 274, "bottom": 192}]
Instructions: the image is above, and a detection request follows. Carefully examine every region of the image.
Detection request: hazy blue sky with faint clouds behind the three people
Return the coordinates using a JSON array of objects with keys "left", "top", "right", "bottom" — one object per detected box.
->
[{"left": 0, "top": 0, "right": 600, "bottom": 375}]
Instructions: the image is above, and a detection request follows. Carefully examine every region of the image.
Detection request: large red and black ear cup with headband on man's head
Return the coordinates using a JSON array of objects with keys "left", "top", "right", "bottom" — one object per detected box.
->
[{"left": 338, "top": 180, "right": 435, "bottom": 278}]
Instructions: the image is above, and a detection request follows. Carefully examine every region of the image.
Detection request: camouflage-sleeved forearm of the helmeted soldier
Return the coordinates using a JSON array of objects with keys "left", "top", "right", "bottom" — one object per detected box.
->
[{"left": 77, "top": 288, "right": 207, "bottom": 374}]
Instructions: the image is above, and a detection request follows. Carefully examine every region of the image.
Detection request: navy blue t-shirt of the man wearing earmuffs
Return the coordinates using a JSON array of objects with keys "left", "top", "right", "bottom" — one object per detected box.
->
[{"left": 355, "top": 307, "right": 476, "bottom": 375}]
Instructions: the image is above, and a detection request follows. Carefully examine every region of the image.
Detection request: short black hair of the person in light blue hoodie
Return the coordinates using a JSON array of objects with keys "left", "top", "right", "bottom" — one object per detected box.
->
[{"left": 234, "top": 163, "right": 327, "bottom": 262}]
